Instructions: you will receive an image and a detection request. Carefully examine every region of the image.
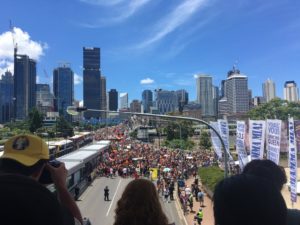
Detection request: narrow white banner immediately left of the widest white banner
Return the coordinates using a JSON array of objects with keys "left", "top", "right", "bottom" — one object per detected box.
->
[{"left": 235, "top": 121, "right": 248, "bottom": 170}]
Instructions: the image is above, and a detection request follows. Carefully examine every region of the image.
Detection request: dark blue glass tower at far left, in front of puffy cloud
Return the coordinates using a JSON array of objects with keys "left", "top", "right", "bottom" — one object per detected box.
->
[{"left": 14, "top": 53, "right": 36, "bottom": 120}]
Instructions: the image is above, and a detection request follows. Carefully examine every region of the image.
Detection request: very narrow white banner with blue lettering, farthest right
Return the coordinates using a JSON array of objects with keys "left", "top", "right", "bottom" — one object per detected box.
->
[{"left": 288, "top": 118, "right": 297, "bottom": 202}]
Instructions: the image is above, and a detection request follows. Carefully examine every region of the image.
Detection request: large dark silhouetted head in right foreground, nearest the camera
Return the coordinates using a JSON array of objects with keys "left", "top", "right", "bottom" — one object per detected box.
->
[{"left": 213, "top": 174, "right": 287, "bottom": 225}]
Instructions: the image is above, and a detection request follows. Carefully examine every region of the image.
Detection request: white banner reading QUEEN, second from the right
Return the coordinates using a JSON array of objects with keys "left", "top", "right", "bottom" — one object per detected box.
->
[{"left": 266, "top": 120, "right": 281, "bottom": 165}]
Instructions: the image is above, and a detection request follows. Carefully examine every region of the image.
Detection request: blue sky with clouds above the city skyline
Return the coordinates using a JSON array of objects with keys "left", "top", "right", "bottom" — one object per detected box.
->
[{"left": 0, "top": 0, "right": 300, "bottom": 103}]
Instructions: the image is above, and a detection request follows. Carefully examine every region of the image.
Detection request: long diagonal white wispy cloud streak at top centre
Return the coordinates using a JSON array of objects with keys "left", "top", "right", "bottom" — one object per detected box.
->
[{"left": 137, "top": 0, "right": 208, "bottom": 48}]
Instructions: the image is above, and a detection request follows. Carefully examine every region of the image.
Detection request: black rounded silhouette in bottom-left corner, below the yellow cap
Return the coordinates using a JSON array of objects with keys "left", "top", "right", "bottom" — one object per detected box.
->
[{"left": 0, "top": 174, "right": 64, "bottom": 225}]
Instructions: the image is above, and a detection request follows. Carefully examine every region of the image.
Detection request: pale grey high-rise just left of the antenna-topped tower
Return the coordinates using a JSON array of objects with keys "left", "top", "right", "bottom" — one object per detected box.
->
[{"left": 196, "top": 75, "right": 214, "bottom": 116}]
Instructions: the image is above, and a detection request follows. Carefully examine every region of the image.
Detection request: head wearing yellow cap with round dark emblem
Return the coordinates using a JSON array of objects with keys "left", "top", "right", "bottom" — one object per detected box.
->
[{"left": 0, "top": 134, "right": 49, "bottom": 179}]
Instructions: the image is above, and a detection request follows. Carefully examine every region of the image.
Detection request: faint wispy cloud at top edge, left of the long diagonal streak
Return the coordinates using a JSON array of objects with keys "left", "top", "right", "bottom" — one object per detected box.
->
[{"left": 81, "top": 0, "right": 150, "bottom": 28}]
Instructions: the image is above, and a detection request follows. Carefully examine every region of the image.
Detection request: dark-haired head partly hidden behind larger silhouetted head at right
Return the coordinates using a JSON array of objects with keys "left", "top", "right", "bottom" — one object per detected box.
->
[{"left": 242, "top": 159, "right": 287, "bottom": 190}]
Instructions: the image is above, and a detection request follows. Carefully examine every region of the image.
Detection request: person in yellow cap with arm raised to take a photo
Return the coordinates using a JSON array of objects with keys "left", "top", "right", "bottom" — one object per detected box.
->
[{"left": 0, "top": 134, "right": 82, "bottom": 224}]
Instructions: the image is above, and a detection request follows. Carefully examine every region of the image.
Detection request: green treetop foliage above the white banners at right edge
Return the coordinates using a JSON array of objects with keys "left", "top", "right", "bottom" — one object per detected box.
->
[{"left": 248, "top": 98, "right": 300, "bottom": 120}]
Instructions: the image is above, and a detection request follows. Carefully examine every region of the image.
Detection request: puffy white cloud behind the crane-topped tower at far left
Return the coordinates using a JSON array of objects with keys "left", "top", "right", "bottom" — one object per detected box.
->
[{"left": 0, "top": 27, "right": 48, "bottom": 74}]
